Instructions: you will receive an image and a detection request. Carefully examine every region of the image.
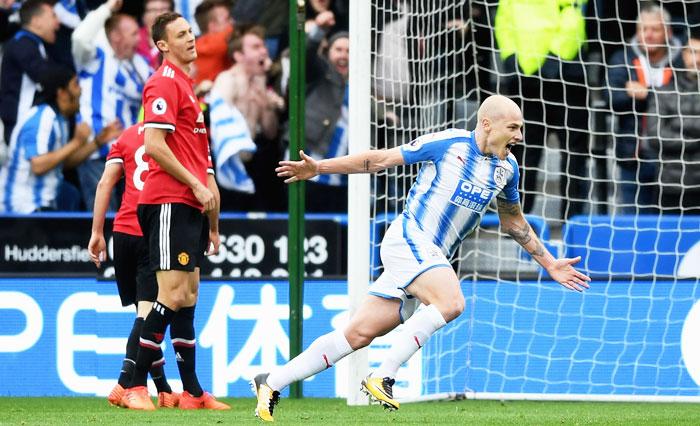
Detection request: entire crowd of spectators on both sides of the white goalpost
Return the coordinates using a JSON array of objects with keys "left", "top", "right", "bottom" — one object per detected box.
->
[{"left": 0, "top": 0, "right": 700, "bottom": 218}]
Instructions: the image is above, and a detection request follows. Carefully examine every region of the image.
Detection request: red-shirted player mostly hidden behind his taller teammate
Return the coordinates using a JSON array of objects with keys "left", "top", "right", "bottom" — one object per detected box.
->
[{"left": 88, "top": 124, "right": 179, "bottom": 407}]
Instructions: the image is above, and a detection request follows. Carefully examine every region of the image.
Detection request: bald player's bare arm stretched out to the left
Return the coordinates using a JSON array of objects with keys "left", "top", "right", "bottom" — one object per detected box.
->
[{"left": 275, "top": 147, "right": 405, "bottom": 183}]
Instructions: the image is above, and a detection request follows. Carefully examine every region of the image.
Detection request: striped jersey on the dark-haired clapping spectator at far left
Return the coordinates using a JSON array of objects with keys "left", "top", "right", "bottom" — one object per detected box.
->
[{"left": 0, "top": 104, "right": 68, "bottom": 213}]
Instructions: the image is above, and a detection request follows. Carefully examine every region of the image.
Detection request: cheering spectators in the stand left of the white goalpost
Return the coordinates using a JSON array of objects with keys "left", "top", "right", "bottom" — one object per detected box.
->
[{"left": 0, "top": 0, "right": 348, "bottom": 213}]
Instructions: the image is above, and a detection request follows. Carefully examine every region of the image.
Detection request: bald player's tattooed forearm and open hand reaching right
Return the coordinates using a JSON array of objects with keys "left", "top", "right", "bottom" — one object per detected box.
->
[{"left": 497, "top": 198, "right": 591, "bottom": 291}]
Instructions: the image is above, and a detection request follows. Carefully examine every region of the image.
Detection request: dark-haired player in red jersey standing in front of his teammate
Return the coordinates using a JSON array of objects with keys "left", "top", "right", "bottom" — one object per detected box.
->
[{"left": 122, "top": 13, "right": 230, "bottom": 410}]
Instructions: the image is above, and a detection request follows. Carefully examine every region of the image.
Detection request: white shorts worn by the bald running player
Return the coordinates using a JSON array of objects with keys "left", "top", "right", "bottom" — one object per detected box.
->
[{"left": 369, "top": 216, "right": 452, "bottom": 322}]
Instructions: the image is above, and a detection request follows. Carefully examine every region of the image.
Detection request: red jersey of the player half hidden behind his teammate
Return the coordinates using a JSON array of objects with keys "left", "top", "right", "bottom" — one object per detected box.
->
[{"left": 105, "top": 123, "right": 148, "bottom": 237}]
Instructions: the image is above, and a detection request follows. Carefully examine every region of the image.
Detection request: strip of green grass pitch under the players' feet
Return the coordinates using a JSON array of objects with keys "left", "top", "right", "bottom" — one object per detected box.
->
[{"left": 0, "top": 398, "right": 700, "bottom": 426}]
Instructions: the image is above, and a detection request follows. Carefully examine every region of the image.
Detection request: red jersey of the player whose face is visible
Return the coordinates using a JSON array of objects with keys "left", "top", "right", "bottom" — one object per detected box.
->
[{"left": 139, "top": 60, "right": 211, "bottom": 209}]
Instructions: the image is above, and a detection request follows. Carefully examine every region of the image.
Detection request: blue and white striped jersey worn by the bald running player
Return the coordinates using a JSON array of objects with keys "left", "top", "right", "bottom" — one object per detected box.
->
[{"left": 401, "top": 129, "right": 520, "bottom": 261}]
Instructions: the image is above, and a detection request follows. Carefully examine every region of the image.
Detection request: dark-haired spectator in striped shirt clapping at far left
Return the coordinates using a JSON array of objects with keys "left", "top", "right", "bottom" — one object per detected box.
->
[{"left": 0, "top": 67, "right": 121, "bottom": 213}]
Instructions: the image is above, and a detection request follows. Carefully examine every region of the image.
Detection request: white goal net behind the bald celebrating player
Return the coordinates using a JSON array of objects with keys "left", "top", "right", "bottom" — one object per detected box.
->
[{"left": 348, "top": 0, "right": 700, "bottom": 401}]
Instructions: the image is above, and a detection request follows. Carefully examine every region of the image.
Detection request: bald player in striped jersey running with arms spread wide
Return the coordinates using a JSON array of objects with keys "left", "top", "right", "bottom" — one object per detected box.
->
[{"left": 252, "top": 96, "right": 590, "bottom": 421}]
